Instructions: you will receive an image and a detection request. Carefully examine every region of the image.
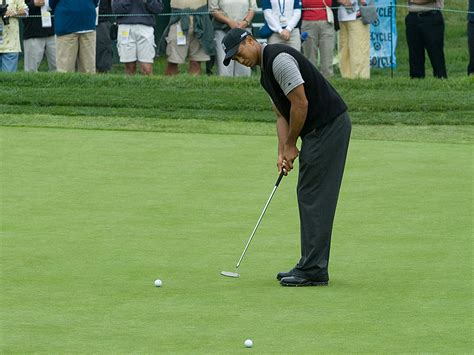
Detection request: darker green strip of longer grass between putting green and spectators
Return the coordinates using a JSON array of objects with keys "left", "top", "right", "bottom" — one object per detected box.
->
[{"left": 0, "top": 73, "right": 474, "bottom": 127}]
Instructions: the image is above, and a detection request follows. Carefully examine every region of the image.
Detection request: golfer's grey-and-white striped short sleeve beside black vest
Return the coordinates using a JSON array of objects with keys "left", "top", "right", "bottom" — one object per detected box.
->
[{"left": 272, "top": 53, "right": 304, "bottom": 96}]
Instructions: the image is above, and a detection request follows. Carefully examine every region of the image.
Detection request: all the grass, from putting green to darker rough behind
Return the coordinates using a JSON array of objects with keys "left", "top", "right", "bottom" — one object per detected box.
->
[{"left": 0, "top": 1, "right": 474, "bottom": 354}]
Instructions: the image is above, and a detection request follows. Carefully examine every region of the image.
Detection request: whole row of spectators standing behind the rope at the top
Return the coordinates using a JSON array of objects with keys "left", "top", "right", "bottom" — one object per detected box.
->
[{"left": 0, "top": 0, "right": 474, "bottom": 79}]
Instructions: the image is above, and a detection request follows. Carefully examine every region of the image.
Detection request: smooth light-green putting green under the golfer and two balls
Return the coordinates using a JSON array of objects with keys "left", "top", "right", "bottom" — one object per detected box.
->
[{"left": 0, "top": 126, "right": 474, "bottom": 354}]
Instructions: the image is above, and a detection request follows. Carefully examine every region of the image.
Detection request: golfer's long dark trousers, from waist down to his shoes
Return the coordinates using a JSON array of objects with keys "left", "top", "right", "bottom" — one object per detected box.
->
[{"left": 291, "top": 112, "right": 351, "bottom": 280}]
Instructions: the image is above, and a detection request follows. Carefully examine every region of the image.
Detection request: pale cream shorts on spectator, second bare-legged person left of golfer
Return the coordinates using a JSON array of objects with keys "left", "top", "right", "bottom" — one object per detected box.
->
[{"left": 117, "top": 24, "right": 156, "bottom": 63}]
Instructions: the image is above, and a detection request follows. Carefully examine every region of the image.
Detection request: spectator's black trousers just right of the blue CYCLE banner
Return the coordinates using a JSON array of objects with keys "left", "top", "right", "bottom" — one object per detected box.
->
[{"left": 405, "top": 10, "right": 448, "bottom": 78}]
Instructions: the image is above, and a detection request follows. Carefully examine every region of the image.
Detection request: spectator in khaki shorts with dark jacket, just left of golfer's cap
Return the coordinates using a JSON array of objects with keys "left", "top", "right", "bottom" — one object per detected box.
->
[{"left": 160, "top": 0, "right": 215, "bottom": 75}]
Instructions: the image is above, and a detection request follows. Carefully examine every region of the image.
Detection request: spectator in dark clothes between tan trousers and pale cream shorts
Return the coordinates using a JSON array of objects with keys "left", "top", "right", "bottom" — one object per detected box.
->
[{"left": 95, "top": 0, "right": 113, "bottom": 73}]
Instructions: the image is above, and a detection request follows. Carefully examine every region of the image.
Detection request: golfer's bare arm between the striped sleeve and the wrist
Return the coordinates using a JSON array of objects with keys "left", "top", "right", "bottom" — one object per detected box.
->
[{"left": 285, "top": 84, "right": 308, "bottom": 145}]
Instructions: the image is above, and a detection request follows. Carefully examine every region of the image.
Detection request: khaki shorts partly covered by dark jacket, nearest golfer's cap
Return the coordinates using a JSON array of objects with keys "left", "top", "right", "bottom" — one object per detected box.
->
[{"left": 166, "top": 22, "right": 211, "bottom": 64}]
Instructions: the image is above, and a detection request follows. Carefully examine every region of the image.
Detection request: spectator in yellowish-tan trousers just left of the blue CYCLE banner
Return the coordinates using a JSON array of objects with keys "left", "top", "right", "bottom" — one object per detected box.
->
[{"left": 338, "top": 0, "right": 370, "bottom": 79}]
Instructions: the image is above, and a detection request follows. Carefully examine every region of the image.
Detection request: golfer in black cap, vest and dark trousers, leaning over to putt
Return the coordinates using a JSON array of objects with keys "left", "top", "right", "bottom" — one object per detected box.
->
[{"left": 222, "top": 28, "right": 351, "bottom": 286}]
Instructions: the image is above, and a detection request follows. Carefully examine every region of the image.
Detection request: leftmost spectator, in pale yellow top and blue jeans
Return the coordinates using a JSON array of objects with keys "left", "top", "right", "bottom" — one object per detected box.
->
[{"left": 0, "top": 0, "right": 28, "bottom": 72}]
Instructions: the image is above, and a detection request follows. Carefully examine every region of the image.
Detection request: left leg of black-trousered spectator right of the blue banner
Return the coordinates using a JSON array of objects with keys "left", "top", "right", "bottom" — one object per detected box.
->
[{"left": 405, "top": 13, "right": 425, "bottom": 78}]
